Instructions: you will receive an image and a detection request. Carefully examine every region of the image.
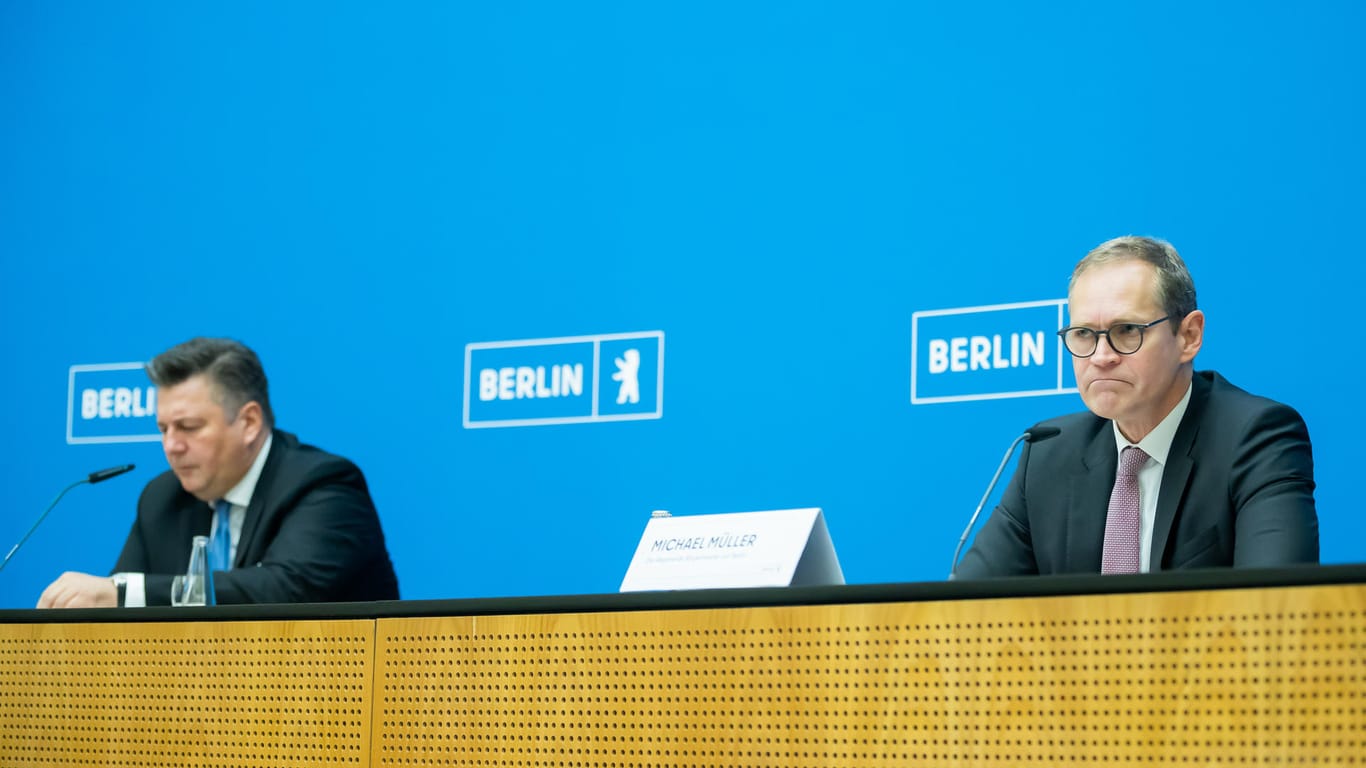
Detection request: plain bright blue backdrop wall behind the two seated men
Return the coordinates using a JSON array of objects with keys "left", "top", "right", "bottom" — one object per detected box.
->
[{"left": 0, "top": 1, "right": 1366, "bottom": 607}]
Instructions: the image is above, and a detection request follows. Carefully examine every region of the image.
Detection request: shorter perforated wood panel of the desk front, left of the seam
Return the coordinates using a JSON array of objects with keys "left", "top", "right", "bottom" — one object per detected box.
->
[{"left": 0, "top": 620, "right": 374, "bottom": 767}]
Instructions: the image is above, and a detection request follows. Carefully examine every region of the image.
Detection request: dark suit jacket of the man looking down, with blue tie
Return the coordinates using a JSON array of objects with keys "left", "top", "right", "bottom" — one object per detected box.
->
[{"left": 113, "top": 429, "right": 399, "bottom": 605}]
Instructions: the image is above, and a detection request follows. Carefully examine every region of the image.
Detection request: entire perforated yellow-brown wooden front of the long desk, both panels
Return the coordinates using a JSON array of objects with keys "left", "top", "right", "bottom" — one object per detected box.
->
[{"left": 0, "top": 585, "right": 1366, "bottom": 768}]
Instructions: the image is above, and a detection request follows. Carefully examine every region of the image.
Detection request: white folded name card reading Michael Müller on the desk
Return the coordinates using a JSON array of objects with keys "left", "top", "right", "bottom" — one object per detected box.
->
[{"left": 622, "top": 508, "right": 844, "bottom": 592}]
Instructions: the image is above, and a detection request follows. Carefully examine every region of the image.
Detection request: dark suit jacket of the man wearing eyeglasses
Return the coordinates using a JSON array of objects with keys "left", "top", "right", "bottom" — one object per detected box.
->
[{"left": 958, "top": 372, "right": 1318, "bottom": 578}]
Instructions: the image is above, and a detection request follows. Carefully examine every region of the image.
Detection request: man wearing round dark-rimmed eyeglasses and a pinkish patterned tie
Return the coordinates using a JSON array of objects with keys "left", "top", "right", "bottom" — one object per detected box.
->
[{"left": 956, "top": 236, "right": 1318, "bottom": 578}]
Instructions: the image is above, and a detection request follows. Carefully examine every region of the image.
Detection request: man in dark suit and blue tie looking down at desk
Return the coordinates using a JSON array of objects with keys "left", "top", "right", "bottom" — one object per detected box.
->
[{"left": 38, "top": 339, "right": 399, "bottom": 608}]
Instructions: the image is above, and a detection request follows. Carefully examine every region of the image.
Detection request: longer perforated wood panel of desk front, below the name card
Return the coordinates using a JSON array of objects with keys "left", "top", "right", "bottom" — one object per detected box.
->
[{"left": 373, "top": 586, "right": 1366, "bottom": 768}]
